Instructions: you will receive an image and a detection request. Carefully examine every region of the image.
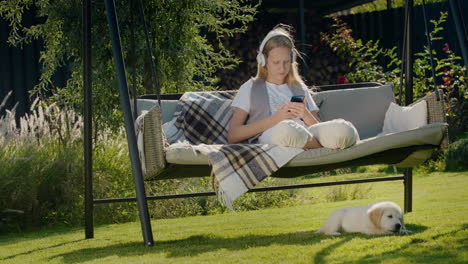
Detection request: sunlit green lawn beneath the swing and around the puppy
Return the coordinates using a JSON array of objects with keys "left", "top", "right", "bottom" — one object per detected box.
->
[{"left": 0, "top": 172, "right": 468, "bottom": 263}]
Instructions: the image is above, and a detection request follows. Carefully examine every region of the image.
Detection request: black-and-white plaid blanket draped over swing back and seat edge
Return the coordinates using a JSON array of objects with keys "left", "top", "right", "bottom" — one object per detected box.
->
[{"left": 163, "top": 91, "right": 304, "bottom": 210}]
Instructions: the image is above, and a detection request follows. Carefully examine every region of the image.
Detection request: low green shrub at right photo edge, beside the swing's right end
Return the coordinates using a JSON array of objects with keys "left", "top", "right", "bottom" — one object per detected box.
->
[{"left": 445, "top": 138, "right": 468, "bottom": 171}]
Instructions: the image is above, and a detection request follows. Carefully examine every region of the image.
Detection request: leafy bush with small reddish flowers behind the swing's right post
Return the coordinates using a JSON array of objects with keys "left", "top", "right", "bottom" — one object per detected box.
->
[{"left": 322, "top": 12, "right": 468, "bottom": 139}]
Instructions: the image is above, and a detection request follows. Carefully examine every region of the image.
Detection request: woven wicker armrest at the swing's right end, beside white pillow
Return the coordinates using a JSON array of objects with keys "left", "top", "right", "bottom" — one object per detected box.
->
[{"left": 410, "top": 89, "right": 449, "bottom": 148}]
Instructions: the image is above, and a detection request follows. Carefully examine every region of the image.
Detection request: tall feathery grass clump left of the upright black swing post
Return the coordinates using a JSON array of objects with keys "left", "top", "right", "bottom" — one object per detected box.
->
[{"left": 0, "top": 93, "right": 83, "bottom": 230}]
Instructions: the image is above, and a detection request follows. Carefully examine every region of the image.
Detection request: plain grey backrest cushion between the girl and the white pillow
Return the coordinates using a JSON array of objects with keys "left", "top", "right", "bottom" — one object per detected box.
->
[{"left": 313, "top": 84, "right": 395, "bottom": 140}]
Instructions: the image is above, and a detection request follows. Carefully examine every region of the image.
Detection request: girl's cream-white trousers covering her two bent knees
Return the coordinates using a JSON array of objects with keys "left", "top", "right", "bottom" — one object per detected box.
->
[{"left": 259, "top": 119, "right": 359, "bottom": 149}]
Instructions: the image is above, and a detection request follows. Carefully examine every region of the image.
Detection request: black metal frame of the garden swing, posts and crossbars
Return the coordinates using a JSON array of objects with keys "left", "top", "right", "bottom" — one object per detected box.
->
[{"left": 83, "top": 0, "right": 422, "bottom": 246}]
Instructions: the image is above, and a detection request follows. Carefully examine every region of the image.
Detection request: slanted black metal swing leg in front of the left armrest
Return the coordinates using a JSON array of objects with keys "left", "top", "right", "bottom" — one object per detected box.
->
[{"left": 105, "top": 0, "right": 154, "bottom": 246}]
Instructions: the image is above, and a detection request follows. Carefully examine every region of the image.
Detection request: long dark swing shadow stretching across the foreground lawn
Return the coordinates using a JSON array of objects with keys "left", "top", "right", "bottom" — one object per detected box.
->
[{"left": 50, "top": 225, "right": 434, "bottom": 263}]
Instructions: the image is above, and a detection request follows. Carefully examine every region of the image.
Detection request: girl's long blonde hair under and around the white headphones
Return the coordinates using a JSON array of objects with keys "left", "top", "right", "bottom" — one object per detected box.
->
[{"left": 255, "top": 24, "right": 305, "bottom": 87}]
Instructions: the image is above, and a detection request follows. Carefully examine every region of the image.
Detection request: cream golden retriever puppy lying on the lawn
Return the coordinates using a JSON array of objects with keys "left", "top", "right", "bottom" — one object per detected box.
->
[{"left": 316, "top": 202, "right": 406, "bottom": 235}]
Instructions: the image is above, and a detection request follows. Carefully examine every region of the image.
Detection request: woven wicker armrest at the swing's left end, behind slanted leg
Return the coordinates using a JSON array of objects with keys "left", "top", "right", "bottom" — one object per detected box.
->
[{"left": 142, "top": 105, "right": 169, "bottom": 180}]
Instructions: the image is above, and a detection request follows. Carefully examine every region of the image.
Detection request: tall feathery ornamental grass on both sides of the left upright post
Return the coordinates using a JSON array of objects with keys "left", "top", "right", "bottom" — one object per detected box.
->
[{"left": 0, "top": 93, "right": 146, "bottom": 232}]
